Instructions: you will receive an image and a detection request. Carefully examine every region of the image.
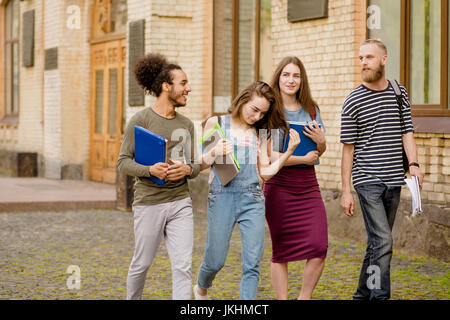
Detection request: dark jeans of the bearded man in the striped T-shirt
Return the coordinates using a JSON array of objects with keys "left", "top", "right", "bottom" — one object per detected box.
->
[{"left": 353, "top": 183, "right": 401, "bottom": 300}]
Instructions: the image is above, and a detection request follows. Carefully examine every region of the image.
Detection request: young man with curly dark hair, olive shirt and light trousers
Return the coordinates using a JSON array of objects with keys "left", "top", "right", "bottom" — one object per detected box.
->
[{"left": 118, "top": 54, "right": 200, "bottom": 300}]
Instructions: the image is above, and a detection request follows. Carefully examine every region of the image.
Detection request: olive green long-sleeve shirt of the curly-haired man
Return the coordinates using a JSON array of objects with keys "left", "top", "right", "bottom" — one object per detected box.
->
[{"left": 117, "top": 107, "right": 200, "bottom": 205}]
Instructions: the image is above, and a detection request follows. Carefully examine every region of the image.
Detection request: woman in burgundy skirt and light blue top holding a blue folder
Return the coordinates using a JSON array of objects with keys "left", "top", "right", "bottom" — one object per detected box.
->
[{"left": 264, "top": 57, "right": 328, "bottom": 299}]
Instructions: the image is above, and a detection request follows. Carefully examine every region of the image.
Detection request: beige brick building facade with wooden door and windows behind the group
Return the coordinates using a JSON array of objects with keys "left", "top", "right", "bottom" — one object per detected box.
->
[{"left": 0, "top": 0, "right": 450, "bottom": 257}]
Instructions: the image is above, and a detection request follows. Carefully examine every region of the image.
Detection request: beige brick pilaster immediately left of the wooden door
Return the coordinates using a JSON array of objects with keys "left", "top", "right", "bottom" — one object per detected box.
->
[{"left": 58, "top": 0, "right": 92, "bottom": 173}]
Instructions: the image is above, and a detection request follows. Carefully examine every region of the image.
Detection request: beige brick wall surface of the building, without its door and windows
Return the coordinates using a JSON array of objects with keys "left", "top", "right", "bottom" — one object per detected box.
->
[{"left": 5, "top": 0, "right": 450, "bottom": 203}]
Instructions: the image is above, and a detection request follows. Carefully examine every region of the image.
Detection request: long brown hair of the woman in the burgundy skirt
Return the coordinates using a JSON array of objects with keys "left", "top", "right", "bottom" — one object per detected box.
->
[{"left": 270, "top": 56, "right": 319, "bottom": 118}]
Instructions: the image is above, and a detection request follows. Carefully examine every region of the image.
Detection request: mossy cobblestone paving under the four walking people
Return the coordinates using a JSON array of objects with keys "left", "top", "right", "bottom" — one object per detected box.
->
[{"left": 0, "top": 210, "right": 450, "bottom": 300}]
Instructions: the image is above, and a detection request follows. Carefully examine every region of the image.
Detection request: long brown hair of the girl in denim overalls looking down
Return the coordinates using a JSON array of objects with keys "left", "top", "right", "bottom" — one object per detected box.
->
[{"left": 227, "top": 81, "right": 289, "bottom": 136}]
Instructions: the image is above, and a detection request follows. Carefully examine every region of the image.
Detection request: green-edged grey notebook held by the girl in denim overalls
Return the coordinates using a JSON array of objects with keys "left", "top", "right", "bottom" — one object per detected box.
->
[{"left": 201, "top": 123, "right": 240, "bottom": 186}]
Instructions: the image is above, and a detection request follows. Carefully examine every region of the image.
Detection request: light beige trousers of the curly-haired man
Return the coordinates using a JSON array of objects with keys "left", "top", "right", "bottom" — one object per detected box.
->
[{"left": 127, "top": 198, "right": 194, "bottom": 300}]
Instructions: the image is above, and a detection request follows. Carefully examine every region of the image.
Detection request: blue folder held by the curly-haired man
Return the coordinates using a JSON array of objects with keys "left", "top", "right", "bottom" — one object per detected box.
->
[{"left": 134, "top": 126, "right": 167, "bottom": 185}]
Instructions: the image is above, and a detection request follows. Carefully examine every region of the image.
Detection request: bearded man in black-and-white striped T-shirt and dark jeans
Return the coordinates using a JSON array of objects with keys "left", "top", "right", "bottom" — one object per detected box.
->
[{"left": 340, "top": 39, "right": 424, "bottom": 300}]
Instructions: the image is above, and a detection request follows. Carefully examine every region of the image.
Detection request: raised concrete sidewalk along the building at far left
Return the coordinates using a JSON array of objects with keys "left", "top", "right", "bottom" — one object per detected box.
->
[{"left": 0, "top": 177, "right": 116, "bottom": 211}]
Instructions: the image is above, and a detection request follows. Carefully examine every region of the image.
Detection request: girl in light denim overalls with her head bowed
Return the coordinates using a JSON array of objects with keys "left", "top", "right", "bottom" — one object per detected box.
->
[{"left": 194, "top": 81, "right": 300, "bottom": 300}]
